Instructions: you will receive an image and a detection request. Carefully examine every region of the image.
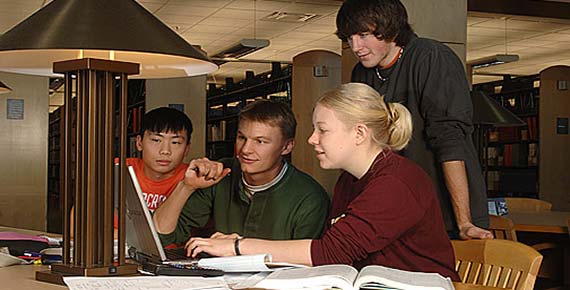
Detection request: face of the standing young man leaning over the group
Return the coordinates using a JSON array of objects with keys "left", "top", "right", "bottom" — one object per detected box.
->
[{"left": 348, "top": 32, "right": 399, "bottom": 68}]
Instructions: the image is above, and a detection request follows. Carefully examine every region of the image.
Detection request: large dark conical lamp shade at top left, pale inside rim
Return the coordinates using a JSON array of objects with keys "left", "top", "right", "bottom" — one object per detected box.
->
[{"left": 0, "top": 0, "right": 218, "bottom": 78}]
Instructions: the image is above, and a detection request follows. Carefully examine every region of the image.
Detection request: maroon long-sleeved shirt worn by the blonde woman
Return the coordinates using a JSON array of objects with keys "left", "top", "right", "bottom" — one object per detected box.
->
[{"left": 311, "top": 151, "right": 459, "bottom": 281}]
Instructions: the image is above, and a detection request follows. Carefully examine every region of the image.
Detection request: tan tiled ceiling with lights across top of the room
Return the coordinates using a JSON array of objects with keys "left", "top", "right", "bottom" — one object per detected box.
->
[{"left": 0, "top": 0, "right": 570, "bottom": 83}]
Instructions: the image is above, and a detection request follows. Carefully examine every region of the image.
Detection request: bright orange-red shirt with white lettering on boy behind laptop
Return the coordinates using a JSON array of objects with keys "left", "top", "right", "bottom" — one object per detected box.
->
[{"left": 127, "top": 158, "right": 188, "bottom": 212}]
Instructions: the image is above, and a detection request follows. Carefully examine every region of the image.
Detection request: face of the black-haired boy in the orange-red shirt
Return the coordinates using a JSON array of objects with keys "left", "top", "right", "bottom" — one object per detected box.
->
[{"left": 137, "top": 130, "right": 190, "bottom": 180}]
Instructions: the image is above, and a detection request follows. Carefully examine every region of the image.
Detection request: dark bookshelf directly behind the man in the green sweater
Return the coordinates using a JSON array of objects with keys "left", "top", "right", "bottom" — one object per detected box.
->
[{"left": 206, "top": 63, "right": 292, "bottom": 160}]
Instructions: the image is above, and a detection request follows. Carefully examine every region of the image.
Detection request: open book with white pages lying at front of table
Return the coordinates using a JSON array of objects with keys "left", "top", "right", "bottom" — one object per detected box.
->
[{"left": 254, "top": 265, "right": 454, "bottom": 290}]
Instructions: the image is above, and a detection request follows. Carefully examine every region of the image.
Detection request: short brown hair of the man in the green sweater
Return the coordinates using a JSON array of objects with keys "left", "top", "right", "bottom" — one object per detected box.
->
[{"left": 239, "top": 100, "right": 297, "bottom": 139}]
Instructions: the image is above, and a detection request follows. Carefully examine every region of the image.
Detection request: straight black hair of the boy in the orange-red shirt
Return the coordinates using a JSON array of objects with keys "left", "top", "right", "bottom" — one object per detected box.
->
[{"left": 140, "top": 107, "right": 192, "bottom": 144}]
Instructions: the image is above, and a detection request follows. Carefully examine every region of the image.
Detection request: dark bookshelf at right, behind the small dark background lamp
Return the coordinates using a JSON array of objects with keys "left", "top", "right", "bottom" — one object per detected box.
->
[{"left": 473, "top": 75, "right": 540, "bottom": 198}]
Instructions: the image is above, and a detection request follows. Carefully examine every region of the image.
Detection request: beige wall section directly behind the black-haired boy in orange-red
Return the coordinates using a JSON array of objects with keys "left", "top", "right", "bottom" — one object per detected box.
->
[{"left": 145, "top": 76, "right": 206, "bottom": 162}]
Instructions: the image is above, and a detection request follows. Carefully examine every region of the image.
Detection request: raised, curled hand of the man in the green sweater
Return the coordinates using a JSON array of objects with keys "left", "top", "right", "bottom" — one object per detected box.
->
[{"left": 184, "top": 157, "right": 231, "bottom": 189}]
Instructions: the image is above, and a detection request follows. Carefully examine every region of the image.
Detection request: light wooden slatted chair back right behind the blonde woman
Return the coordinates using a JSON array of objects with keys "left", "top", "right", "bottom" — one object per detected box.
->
[{"left": 451, "top": 239, "right": 542, "bottom": 290}]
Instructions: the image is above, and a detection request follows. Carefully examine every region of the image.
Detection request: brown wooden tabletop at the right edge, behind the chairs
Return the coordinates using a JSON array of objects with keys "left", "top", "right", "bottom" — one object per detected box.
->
[{"left": 508, "top": 211, "right": 570, "bottom": 234}]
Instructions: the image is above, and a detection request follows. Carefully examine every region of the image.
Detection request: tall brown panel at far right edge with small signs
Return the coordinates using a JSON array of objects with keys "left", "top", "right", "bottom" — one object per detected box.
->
[{"left": 538, "top": 65, "right": 570, "bottom": 211}]
